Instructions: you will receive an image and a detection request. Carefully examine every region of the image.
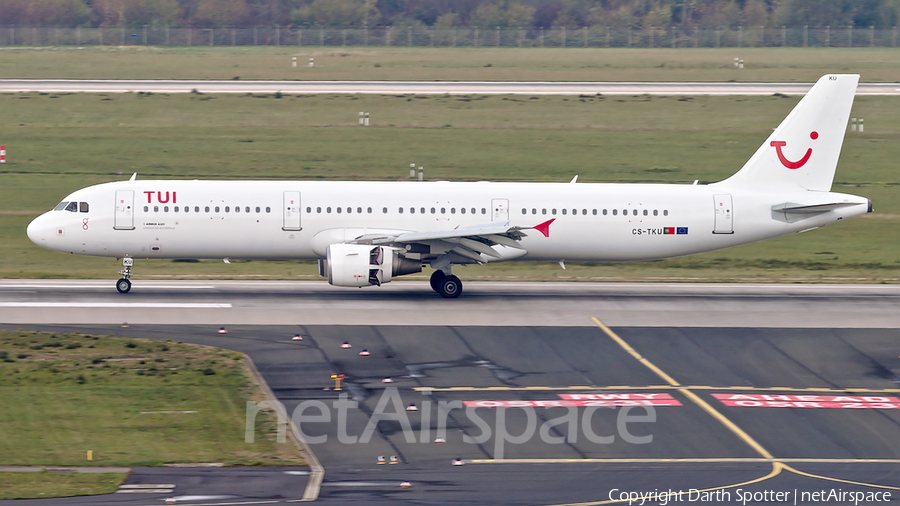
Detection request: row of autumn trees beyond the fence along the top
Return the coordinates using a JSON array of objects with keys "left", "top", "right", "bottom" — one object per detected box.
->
[{"left": 0, "top": 0, "right": 900, "bottom": 30}]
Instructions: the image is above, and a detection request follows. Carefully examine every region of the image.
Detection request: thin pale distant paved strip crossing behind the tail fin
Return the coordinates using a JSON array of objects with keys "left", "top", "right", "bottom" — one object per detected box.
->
[{"left": 0, "top": 79, "right": 900, "bottom": 96}]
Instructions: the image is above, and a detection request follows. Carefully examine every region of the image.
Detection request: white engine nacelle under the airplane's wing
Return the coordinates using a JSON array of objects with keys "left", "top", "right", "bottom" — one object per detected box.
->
[{"left": 319, "top": 244, "right": 422, "bottom": 287}]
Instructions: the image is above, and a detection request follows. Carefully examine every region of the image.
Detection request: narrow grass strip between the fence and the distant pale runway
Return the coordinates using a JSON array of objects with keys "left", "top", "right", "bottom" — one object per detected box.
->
[{"left": 0, "top": 46, "right": 900, "bottom": 82}]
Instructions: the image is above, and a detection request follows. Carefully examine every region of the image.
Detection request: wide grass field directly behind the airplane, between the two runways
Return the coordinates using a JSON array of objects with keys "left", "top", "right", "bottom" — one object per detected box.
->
[{"left": 0, "top": 80, "right": 900, "bottom": 282}]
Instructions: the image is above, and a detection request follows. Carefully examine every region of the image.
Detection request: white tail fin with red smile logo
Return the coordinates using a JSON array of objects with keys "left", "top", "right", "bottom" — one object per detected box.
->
[{"left": 725, "top": 74, "right": 859, "bottom": 191}]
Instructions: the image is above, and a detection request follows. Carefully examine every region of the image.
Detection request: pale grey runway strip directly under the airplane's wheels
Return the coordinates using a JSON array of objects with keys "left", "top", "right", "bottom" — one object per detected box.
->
[{"left": 0, "top": 280, "right": 900, "bottom": 328}]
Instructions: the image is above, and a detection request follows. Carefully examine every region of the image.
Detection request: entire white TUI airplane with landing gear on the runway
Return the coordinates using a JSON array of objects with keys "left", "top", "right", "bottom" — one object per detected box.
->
[{"left": 27, "top": 74, "right": 872, "bottom": 298}]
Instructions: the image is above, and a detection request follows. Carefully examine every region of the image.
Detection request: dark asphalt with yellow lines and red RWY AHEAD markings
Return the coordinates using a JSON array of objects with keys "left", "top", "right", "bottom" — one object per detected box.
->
[{"left": 6, "top": 323, "right": 900, "bottom": 504}]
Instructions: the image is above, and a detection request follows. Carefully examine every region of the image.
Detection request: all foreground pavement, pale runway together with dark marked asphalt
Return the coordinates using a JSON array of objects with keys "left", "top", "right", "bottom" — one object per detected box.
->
[{"left": 0, "top": 280, "right": 900, "bottom": 506}]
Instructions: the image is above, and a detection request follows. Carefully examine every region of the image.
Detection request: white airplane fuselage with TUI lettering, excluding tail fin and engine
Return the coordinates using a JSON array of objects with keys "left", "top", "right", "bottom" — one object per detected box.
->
[{"left": 28, "top": 180, "right": 868, "bottom": 261}]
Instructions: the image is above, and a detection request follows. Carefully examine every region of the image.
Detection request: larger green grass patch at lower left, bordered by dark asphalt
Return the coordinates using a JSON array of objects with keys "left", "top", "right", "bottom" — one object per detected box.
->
[{"left": 0, "top": 331, "right": 303, "bottom": 470}]
